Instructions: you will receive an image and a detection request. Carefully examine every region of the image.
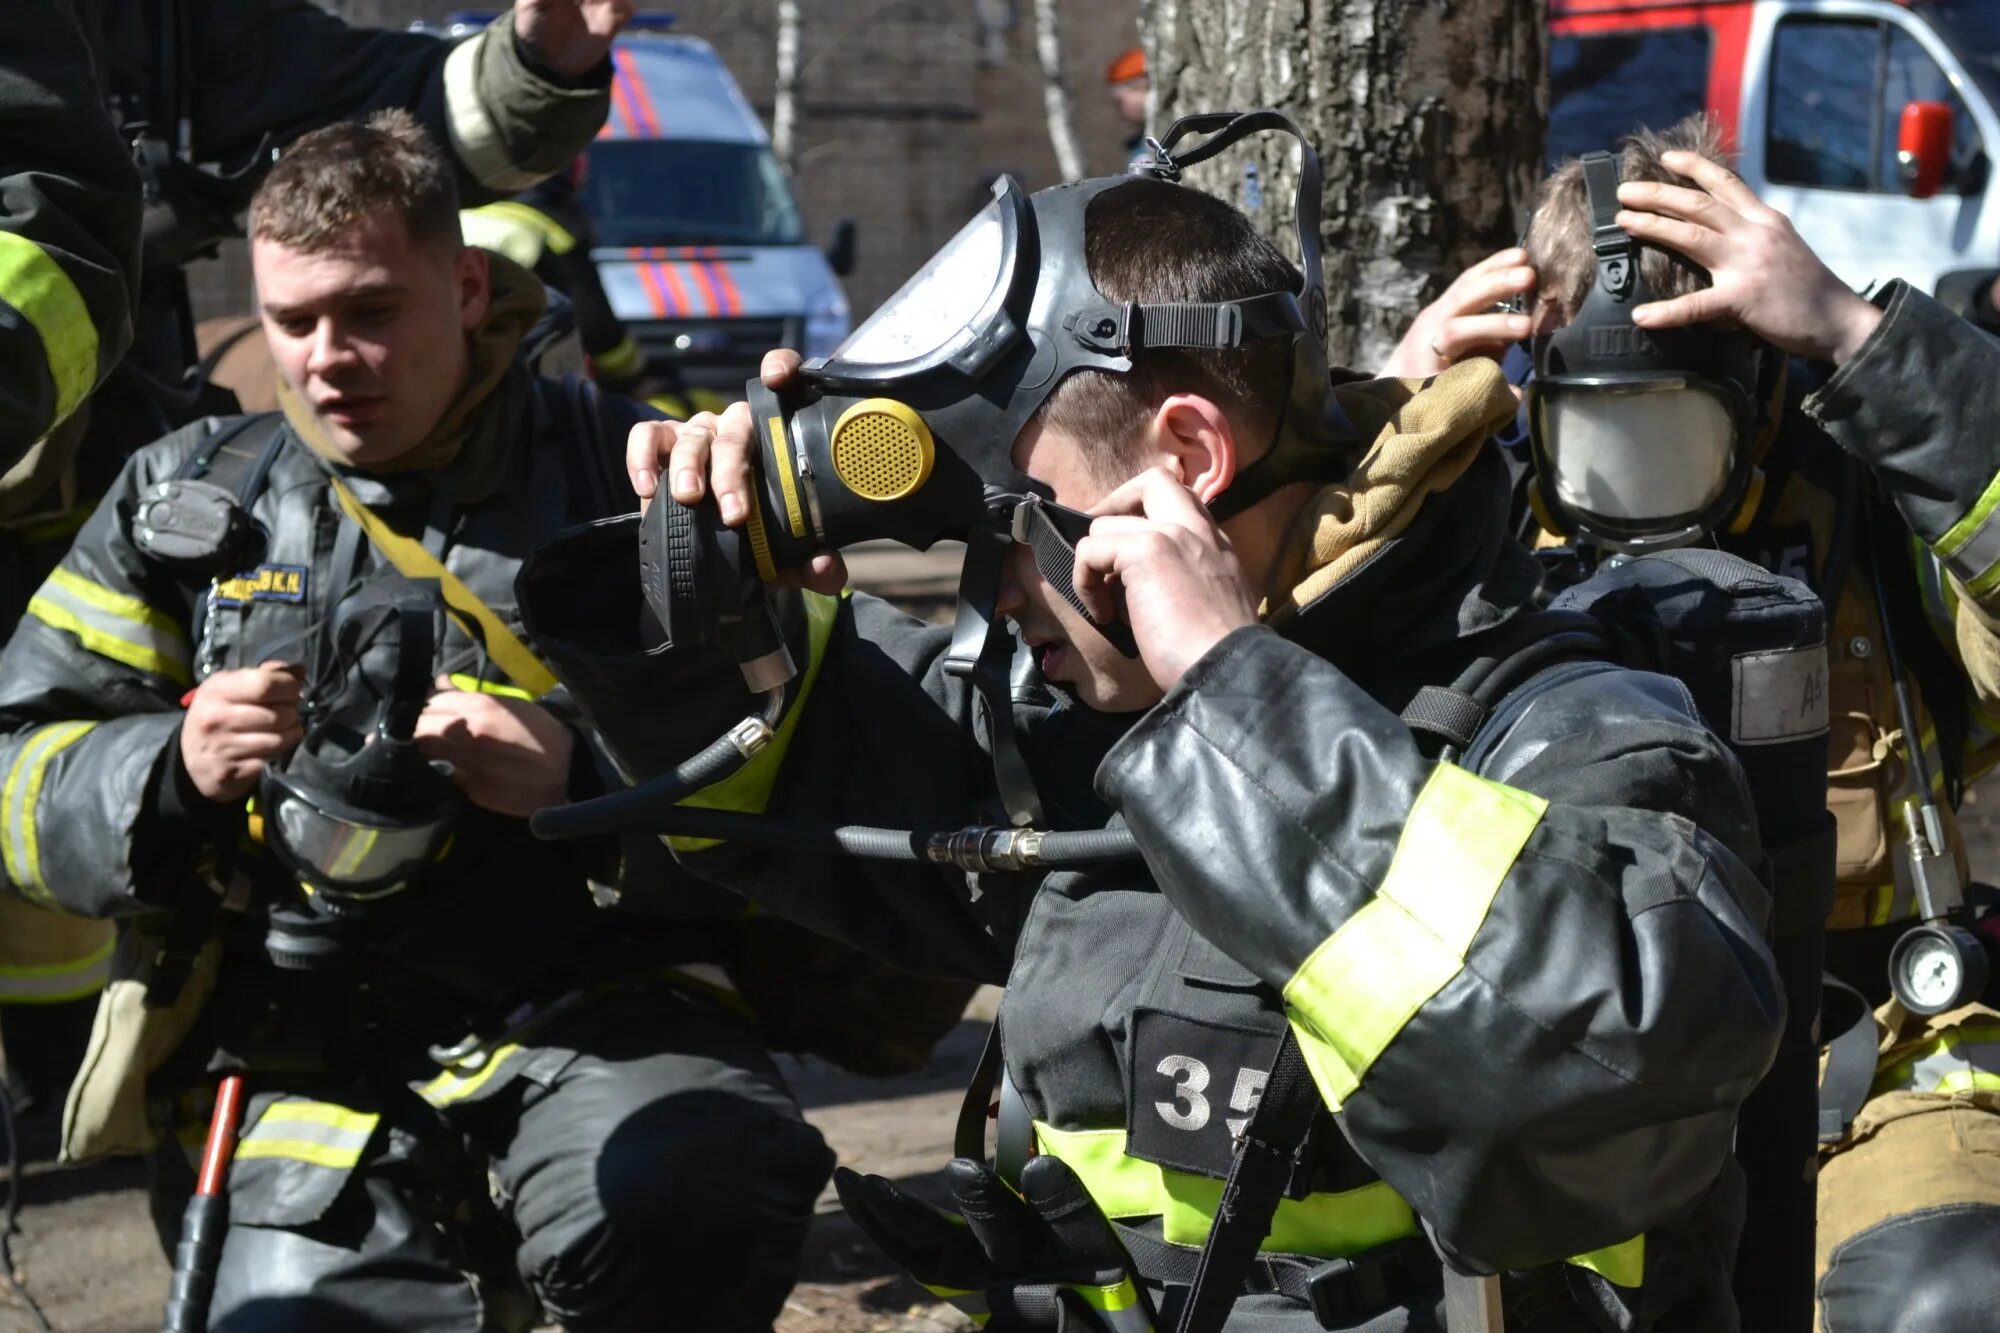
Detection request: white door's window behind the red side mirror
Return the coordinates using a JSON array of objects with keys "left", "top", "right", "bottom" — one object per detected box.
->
[{"left": 1764, "top": 18, "right": 1986, "bottom": 194}]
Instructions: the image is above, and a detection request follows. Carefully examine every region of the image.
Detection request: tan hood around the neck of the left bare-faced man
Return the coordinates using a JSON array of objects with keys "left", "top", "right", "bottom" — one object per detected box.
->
[{"left": 278, "top": 254, "right": 548, "bottom": 488}]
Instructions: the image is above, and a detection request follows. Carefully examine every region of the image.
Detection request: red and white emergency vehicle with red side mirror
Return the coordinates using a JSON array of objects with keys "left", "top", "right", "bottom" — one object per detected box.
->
[{"left": 1548, "top": 0, "right": 2000, "bottom": 298}]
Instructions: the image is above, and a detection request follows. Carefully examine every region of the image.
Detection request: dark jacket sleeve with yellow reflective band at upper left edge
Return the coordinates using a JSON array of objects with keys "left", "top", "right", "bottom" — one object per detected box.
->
[{"left": 0, "top": 0, "right": 140, "bottom": 472}]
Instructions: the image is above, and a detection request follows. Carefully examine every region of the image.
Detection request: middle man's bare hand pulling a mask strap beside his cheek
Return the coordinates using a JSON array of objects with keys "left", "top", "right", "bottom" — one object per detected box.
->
[{"left": 1076, "top": 468, "right": 1258, "bottom": 691}]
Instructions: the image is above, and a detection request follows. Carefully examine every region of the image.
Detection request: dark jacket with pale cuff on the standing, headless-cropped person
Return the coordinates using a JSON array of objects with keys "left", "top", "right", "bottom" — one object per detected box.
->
[{"left": 0, "top": 0, "right": 610, "bottom": 524}]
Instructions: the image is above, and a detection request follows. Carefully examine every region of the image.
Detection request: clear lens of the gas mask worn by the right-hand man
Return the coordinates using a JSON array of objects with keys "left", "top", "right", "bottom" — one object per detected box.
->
[{"left": 1536, "top": 380, "right": 1736, "bottom": 528}]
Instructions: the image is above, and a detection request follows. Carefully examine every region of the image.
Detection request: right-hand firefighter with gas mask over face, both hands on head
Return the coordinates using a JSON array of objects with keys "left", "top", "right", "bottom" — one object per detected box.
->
[{"left": 1398, "top": 120, "right": 2000, "bottom": 1333}]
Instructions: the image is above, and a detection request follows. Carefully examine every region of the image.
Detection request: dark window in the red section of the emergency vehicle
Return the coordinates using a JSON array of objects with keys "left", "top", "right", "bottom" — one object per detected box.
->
[{"left": 1548, "top": 28, "right": 1710, "bottom": 170}]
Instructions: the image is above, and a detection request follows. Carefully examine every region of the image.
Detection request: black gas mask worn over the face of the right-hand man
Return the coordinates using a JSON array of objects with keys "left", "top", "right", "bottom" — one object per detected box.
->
[{"left": 1526, "top": 152, "right": 1780, "bottom": 552}]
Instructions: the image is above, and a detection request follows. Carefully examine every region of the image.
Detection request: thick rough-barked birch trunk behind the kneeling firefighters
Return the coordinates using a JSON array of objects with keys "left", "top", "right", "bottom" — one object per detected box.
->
[{"left": 1140, "top": 0, "right": 1548, "bottom": 370}]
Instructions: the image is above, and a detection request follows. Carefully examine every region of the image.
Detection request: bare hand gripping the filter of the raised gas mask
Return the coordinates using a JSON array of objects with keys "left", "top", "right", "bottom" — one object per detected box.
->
[{"left": 626, "top": 348, "right": 848, "bottom": 594}]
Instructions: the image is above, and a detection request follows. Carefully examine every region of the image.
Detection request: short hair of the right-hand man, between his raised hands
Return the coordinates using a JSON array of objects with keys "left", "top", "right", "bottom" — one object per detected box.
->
[{"left": 1524, "top": 112, "right": 1730, "bottom": 318}]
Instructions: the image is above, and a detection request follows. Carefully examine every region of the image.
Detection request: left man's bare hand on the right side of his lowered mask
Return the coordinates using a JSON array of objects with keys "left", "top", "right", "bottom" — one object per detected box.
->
[{"left": 416, "top": 677, "right": 576, "bottom": 819}]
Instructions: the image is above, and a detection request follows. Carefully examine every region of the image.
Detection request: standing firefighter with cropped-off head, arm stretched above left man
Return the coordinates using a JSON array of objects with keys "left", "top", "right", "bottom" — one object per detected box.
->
[{"left": 0, "top": 0, "right": 632, "bottom": 1120}]
